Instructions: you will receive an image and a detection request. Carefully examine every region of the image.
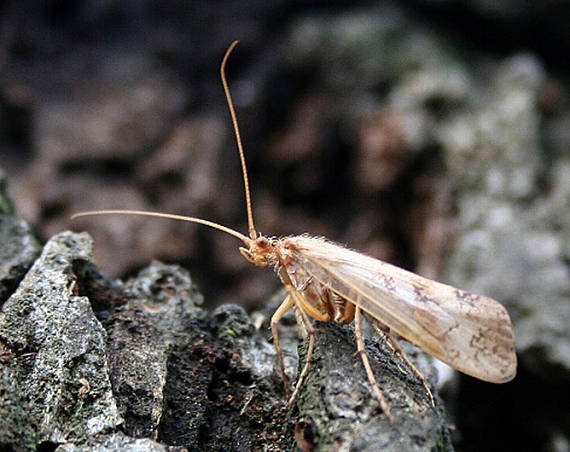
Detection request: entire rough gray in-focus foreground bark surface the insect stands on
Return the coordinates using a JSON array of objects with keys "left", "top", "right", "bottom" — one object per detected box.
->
[{"left": 0, "top": 232, "right": 451, "bottom": 451}]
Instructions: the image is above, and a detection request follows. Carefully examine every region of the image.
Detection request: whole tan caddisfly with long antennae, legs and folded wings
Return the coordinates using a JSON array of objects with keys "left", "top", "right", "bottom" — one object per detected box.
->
[{"left": 72, "top": 41, "right": 517, "bottom": 421}]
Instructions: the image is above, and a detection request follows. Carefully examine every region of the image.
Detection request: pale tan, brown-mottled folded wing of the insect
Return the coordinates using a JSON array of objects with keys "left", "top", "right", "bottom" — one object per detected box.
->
[{"left": 287, "top": 236, "right": 517, "bottom": 383}]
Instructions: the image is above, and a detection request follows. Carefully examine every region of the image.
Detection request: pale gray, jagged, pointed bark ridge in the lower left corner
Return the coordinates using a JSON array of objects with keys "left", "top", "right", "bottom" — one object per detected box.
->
[{"left": 0, "top": 232, "right": 122, "bottom": 450}]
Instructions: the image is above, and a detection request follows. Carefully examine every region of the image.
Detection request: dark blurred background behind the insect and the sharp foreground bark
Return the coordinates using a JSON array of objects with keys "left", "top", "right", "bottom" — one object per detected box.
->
[{"left": 0, "top": 0, "right": 570, "bottom": 452}]
